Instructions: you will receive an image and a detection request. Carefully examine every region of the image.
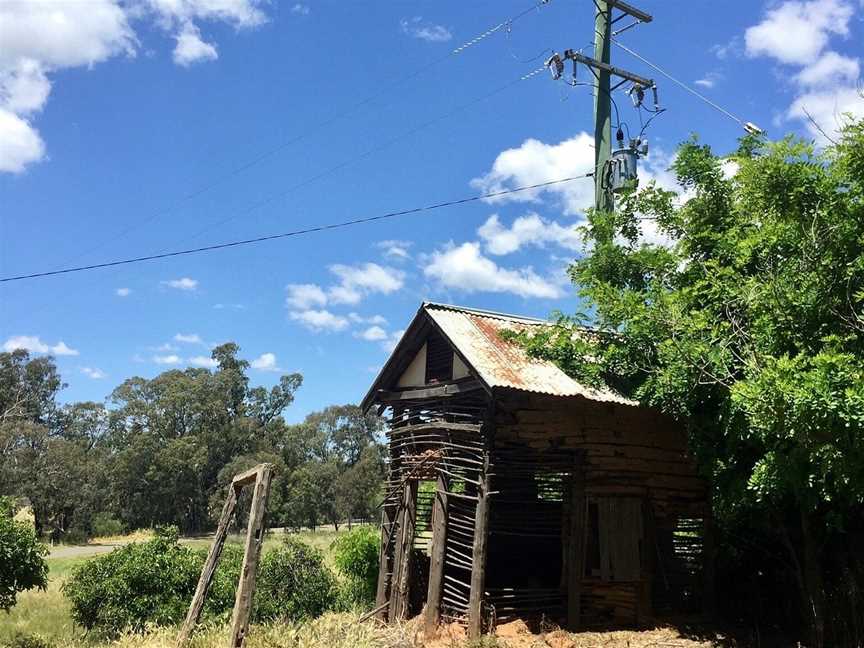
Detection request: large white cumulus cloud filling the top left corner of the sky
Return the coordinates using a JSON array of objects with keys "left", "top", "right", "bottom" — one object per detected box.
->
[{"left": 0, "top": 0, "right": 266, "bottom": 173}]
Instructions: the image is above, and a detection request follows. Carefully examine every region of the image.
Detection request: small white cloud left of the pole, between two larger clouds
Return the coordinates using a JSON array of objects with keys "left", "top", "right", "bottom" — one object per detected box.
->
[{"left": 477, "top": 213, "right": 582, "bottom": 255}]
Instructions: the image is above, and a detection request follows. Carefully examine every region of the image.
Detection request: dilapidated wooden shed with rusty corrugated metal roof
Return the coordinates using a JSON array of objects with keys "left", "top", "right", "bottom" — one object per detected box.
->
[{"left": 363, "top": 303, "right": 713, "bottom": 636}]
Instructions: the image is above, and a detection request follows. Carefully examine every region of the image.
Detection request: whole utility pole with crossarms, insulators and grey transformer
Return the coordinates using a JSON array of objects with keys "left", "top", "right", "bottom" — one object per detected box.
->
[{"left": 546, "top": 0, "right": 657, "bottom": 212}]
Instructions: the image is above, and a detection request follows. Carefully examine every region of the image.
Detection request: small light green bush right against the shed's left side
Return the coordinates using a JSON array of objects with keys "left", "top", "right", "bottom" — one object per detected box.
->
[{"left": 332, "top": 526, "right": 380, "bottom": 607}]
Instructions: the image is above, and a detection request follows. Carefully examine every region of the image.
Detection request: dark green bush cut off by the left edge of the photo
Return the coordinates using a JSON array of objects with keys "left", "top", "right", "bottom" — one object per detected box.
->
[{"left": 0, "top": 497, "right": 48, "bottom": 610}]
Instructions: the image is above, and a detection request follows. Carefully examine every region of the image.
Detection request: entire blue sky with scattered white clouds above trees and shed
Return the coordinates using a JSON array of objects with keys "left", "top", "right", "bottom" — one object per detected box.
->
[{"left": 0, "top": 0, "right": 864, "bottom": 420}]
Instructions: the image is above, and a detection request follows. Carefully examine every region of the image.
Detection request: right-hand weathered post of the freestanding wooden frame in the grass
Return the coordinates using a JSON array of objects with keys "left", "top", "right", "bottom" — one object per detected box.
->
[{"left": 228, "top": 464, "right": 273, "bottom": 648}]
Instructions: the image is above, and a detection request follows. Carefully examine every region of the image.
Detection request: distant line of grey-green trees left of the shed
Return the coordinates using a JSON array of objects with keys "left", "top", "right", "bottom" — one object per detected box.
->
[{"left": 0, "top": 342, "right": 383, "bottom": 540}]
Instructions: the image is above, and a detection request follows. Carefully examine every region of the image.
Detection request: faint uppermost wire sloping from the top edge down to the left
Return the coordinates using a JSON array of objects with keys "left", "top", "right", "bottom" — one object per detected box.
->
[{"left": 55, "top": 0, "right": 551, "bottom": 270}]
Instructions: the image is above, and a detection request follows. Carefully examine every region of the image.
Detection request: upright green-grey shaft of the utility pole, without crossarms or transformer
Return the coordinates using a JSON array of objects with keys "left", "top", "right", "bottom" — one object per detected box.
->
[{"left": 594, "top": 0, "right": 615, "bottom": 212}]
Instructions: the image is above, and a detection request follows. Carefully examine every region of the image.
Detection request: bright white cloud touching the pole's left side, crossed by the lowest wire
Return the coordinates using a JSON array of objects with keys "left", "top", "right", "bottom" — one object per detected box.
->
[{"left": 471, "top": 131, "right": 594, "bottom": 215}]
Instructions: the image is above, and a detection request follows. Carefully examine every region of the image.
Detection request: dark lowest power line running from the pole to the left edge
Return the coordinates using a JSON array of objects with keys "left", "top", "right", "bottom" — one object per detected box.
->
[{"left": 0, "top": 172, "right": 593, "bottom": 283}]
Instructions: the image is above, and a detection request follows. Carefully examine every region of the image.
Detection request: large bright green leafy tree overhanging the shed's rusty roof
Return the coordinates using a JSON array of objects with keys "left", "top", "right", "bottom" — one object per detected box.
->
[{"left": 523, "top": 122, "right": 864, "bottom": 646}]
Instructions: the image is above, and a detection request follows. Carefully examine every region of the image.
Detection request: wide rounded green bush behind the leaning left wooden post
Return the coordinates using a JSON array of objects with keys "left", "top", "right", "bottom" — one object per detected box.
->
[{"left": 63, "top": 528, "right": 242, "bottom": 635}]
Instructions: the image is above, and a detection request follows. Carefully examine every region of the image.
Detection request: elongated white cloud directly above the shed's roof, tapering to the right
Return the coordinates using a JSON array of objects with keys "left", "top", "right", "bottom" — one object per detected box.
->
[{"left": 423, "top": 242, "right": 563, "bottom": 299}]
